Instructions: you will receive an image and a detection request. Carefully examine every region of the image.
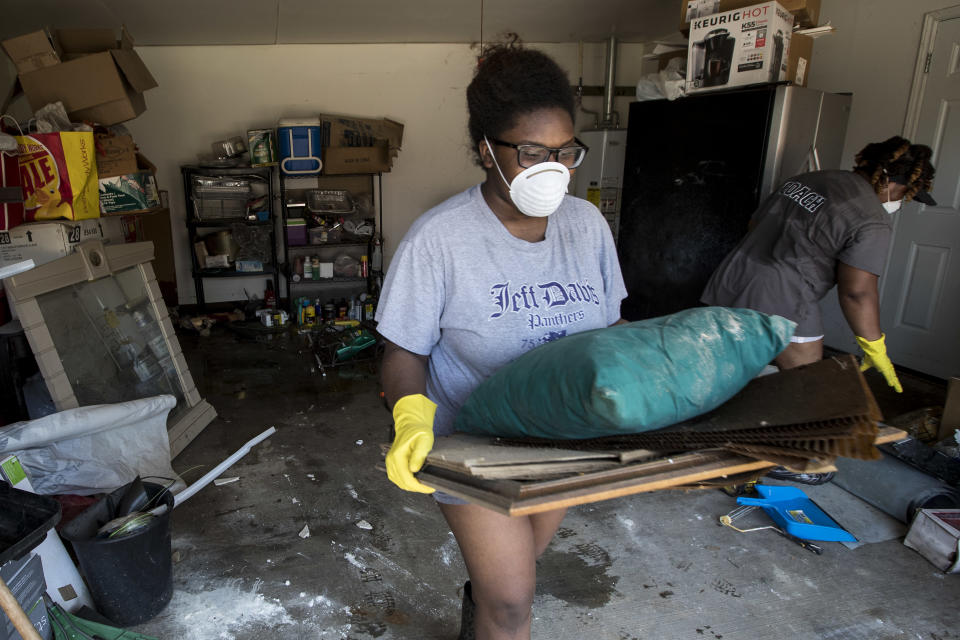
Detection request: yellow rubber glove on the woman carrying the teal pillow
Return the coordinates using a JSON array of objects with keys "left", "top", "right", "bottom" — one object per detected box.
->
[{"left": 387, "top": 393, "right": 437, "bottom": 493}]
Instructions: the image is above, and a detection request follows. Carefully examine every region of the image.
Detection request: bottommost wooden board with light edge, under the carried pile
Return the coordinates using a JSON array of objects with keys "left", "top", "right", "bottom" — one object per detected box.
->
[{"left": 417, "top": 427, "right": 907, "bottom": 516}]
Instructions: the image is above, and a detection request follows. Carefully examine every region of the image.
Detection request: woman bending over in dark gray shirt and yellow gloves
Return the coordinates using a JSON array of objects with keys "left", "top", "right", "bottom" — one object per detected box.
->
[{"left": 700, "top": 136, "right": 936, "bottom": 392}]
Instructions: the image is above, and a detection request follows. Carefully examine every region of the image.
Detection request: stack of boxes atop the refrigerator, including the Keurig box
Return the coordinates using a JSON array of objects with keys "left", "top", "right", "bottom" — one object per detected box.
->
[{"left": 680, "top": 0, "right": 820, "bottom": 93}]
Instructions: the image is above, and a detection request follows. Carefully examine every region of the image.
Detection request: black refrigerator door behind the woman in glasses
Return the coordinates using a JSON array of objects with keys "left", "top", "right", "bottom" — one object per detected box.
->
[{"left": 617, "top": 87, "right": 775, "bottom": 320}]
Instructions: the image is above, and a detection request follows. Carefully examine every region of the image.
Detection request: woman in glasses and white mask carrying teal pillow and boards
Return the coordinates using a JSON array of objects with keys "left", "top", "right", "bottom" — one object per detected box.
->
[{"left": 377, "top": 45, "right": 626, "bottom": 639}]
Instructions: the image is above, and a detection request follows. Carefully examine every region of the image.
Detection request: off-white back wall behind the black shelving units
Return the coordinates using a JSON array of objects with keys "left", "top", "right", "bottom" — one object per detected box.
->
[{"left": 28, "top": 43, "right": 643, "bottom": 304}]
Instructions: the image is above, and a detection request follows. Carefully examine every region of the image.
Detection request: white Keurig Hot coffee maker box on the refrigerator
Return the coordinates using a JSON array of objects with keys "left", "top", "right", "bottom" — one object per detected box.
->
[{"left": 687, "top": 2, "right": 793, "bottom": 94}]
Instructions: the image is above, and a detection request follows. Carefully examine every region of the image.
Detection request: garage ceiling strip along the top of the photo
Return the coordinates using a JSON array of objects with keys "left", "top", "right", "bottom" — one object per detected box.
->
[{"left": 0, "top": 0, "right": 680, "bottom": 45}]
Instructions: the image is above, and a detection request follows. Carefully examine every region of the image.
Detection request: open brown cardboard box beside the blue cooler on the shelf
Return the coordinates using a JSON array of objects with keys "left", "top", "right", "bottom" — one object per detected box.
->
[{"left": 320, "top": 115, "right": 403, "bottom": 175}]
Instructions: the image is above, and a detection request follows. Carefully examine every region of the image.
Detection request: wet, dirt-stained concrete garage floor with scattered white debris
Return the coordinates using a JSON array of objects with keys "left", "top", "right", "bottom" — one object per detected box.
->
[{"left": 129, "top": 327, "right": 960, "bottom": 640}]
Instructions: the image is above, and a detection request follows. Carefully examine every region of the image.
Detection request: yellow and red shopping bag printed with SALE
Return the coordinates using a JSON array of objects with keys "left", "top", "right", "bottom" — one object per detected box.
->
[{"left": 16, "top": 131, "right": 100, "bottom": 221}]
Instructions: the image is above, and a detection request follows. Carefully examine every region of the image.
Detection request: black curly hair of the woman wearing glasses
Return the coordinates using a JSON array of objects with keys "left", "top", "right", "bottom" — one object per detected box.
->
[{"left": 467, "top": 36, "right": 576, "bottom": 164}]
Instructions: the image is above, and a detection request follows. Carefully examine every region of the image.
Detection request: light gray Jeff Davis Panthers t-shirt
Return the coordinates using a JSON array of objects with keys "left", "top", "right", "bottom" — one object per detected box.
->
[{"left": 376, "top": 186, "right": 627, "bottom": 434}]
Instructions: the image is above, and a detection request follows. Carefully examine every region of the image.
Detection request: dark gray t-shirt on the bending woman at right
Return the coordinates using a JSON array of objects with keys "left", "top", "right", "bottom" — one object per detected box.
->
[{"left": 700, "top": 171, "right": 891, "bottom": 337}]
